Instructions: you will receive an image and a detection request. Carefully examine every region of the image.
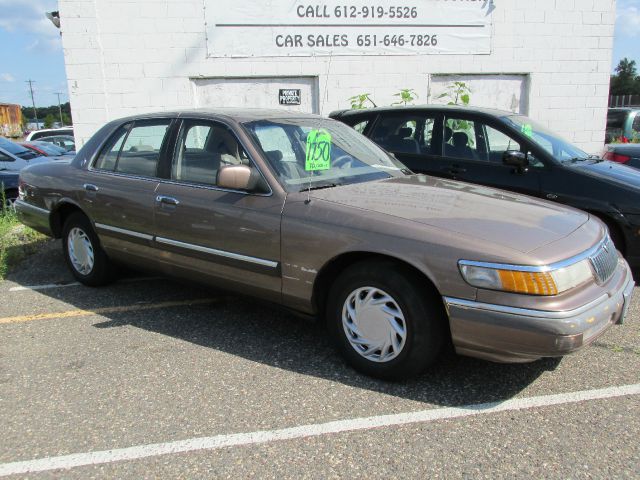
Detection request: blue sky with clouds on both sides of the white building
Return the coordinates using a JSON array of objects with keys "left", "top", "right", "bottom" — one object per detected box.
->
[{"left": 0, "top": 0, "right": 640, "bottom": 107}]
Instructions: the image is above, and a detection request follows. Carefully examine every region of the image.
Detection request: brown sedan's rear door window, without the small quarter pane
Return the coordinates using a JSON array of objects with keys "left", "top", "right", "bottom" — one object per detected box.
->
[{"left": 116, "top": 120, "right": 170, "bottom": 177}]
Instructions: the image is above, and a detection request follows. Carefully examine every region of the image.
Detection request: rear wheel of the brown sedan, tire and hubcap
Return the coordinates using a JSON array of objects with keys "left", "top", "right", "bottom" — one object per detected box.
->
[{"left": 62, "top": 212, "right": 115, "bottom": 287}]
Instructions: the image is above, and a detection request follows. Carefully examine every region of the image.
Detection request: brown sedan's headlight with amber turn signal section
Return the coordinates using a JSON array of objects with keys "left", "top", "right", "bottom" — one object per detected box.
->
[{"left": 458, "top": 258, "right": 593, "bottom": 295}]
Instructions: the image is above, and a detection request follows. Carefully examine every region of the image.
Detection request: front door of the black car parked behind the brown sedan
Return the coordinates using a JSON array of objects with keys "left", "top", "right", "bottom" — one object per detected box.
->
[{"left": 442, "top": 113, "right": 548, "bottom": 196}]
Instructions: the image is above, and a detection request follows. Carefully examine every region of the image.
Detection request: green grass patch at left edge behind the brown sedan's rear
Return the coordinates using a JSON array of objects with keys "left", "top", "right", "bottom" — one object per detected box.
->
[{"left": 0, "top": 204, "right": 47, "bottom": 280}]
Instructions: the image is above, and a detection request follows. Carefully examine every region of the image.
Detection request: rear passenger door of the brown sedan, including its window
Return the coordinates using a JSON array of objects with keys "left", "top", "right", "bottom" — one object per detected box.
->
[{"left": 81, "top": 118, "right": 172, "bottom": 258}]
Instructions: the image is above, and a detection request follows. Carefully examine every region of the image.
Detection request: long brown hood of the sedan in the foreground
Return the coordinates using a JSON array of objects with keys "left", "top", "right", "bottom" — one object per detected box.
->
[{"left": 311, "top": 175, "right": 595, "bottom": 253}]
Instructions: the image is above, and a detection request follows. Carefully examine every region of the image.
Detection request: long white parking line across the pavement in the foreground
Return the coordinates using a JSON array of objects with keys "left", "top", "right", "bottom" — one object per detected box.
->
[{"left": 0, "top": 383, "right": 640, "bottom": 476}]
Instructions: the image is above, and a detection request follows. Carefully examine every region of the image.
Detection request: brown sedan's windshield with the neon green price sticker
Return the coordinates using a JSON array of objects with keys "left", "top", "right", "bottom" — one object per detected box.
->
[{"left": 244, "top": 118, "right": 410, "bottom": 191}]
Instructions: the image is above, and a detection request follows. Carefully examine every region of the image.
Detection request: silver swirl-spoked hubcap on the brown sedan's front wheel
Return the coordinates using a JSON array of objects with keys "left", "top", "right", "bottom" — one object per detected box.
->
[{"left": 342, "top": 287, "right": 407, "bottom": 363}]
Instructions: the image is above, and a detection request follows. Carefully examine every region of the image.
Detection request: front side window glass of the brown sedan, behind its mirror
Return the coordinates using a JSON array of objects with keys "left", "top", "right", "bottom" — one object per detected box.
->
[{"left": 171, "top": 121, "right": 249, "bottom": 185}]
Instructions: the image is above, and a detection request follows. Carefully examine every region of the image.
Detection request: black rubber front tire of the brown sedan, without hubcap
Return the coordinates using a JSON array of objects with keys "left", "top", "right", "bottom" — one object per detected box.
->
[{"left": 326, "top": 261, "right": 447, "bottom": 380}]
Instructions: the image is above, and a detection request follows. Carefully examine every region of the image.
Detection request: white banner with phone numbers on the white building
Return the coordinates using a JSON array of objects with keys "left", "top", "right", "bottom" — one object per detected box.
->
[{"left": 204, "top": 0, "right": 495, "bottom": 57}]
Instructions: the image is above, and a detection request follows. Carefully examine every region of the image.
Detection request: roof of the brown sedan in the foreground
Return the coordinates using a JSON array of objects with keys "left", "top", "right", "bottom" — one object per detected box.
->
[{"left": 109, "top": 107, "right": 323, "bottom": 123}]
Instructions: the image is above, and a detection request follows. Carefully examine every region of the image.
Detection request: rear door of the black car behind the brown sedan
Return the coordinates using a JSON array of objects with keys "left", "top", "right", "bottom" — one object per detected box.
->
[{"left": 365, "top": 110, "right": 446, "bottom": 176}]
